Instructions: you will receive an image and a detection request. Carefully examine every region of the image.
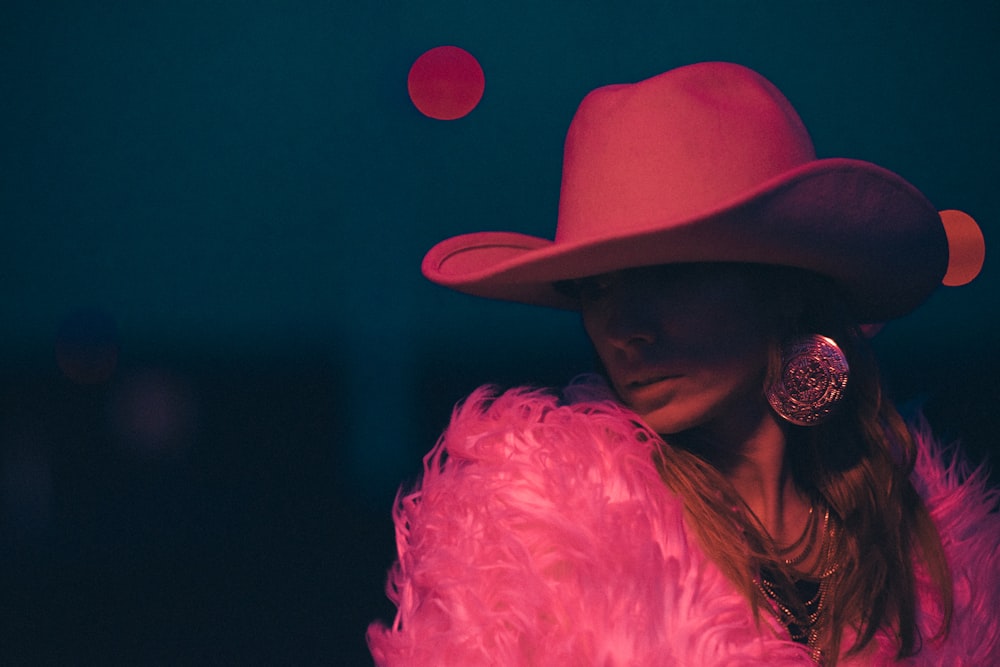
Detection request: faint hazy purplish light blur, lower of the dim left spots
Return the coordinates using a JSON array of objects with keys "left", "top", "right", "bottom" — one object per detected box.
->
[{"left": 111, "top": 371, "right": 196, "bottom": 459}]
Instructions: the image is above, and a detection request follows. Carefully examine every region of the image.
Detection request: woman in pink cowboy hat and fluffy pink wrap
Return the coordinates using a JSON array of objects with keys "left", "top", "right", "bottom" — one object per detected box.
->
[{"left": 368, "top": 63, "right": 1000, "bottom": 665}]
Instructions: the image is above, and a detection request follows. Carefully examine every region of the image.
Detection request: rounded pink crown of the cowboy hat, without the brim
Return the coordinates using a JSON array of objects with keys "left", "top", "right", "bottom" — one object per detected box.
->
[{"left": 555, "top": 62, "right": 816, "bottom": 242}]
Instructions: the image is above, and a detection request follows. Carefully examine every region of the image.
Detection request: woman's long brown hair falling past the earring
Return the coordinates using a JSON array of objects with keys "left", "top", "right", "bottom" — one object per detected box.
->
[{"left": 657, "top": 267, "right": 952, "bottom": 665}]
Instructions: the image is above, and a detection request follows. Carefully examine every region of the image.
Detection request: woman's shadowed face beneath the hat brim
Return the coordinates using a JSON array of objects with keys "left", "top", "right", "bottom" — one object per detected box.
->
[{"left": 578, "top": 264, "right": 775, "bottom": 435}]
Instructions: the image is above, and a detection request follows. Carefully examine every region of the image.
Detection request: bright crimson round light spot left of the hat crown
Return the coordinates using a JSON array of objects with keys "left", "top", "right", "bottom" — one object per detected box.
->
[{"left": 407, "top": 46, "right": 486, "bottom": 120}]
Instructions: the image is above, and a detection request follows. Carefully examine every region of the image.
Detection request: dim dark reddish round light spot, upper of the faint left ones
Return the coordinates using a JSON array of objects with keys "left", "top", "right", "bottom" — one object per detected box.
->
[{"left": 56, "top": 309, "right": 118, "bottom": 384}]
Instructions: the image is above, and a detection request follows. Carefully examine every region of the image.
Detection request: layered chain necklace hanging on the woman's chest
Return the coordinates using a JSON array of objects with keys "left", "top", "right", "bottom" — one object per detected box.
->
[{"left": 754, "top": 507, "right": 840, "bottom": 664}]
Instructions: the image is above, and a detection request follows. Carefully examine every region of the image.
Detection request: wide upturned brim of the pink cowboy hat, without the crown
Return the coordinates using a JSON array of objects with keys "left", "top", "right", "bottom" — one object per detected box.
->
[{"left": 422, "top": 158, "right": 948, "bottom": 322}]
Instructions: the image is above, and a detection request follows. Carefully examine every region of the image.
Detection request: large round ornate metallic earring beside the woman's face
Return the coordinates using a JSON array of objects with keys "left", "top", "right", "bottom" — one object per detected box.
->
[{"left": 765, "top": 334, "right": 850, "bottom": 426}]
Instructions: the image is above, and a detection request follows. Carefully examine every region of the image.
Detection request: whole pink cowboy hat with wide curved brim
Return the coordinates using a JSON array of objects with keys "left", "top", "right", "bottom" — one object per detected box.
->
[{"left": 422, "top": 62, "right": 948, "bottom": 322}]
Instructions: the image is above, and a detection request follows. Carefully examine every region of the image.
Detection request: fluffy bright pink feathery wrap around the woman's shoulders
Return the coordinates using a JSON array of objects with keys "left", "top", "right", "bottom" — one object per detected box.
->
[{"left": 368, "top": 382, "right": 1000, "bottom": 667}]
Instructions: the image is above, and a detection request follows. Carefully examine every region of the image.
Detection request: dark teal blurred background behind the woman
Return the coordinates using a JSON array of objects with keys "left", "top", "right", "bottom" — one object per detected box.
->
[{"left": 0, "top": 0, "right": 1000, "bottom": 665}]
